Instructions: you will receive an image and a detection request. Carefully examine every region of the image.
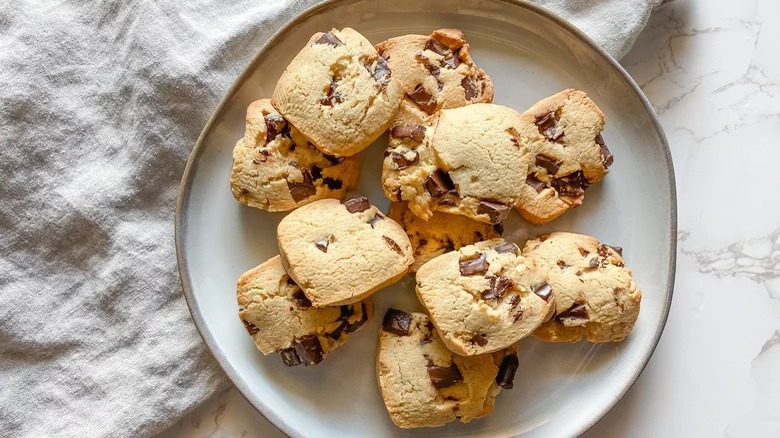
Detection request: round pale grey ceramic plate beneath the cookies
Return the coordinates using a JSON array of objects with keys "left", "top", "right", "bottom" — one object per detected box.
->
[{"left": 176, "top": 0, "right": 676, "bottom": 437}]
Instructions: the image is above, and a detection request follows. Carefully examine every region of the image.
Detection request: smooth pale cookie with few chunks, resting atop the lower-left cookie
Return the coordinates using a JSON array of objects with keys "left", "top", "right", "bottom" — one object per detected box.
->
[{"left": 277, "top": 196, "right": 414, "bottom": 307}]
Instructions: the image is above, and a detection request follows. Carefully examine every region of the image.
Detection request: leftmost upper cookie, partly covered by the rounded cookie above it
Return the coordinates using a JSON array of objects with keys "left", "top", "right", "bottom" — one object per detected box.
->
[{"left": 230, "top": 99, "right": 360, "bottom": 211}]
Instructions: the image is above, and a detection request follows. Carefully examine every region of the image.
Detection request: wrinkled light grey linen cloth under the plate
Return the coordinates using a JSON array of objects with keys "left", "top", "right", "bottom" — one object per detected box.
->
[{"left": 0, "top": 0, "right": 656, "bottom": 437}]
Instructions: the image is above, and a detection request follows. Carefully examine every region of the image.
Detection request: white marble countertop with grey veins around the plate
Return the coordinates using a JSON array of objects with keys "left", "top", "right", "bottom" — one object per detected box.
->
[{"left": 160, "top": 0, "right": 780, "bottom": 438}]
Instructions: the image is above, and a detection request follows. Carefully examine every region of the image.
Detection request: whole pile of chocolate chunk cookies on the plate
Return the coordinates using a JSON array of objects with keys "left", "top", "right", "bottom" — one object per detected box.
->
[{"left": 230, "top": 28, "right": 641, "bottom": 428}]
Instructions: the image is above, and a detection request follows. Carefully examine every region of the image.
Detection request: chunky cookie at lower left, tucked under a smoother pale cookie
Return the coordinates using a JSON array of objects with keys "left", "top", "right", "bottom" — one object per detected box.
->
[{"left": 238, "top": 256, "right": 374, "bottom": 366}]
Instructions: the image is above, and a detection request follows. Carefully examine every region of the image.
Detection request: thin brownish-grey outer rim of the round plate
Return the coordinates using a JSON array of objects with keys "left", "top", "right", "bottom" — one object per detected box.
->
[{"left": 174, "top": 0, "right": 677, "bottom": 436}]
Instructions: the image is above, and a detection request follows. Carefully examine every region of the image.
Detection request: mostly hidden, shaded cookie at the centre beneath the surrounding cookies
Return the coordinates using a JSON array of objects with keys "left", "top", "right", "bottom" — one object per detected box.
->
[{"left": 388, "top": 202, "right": 504, "bottom": 272}]
